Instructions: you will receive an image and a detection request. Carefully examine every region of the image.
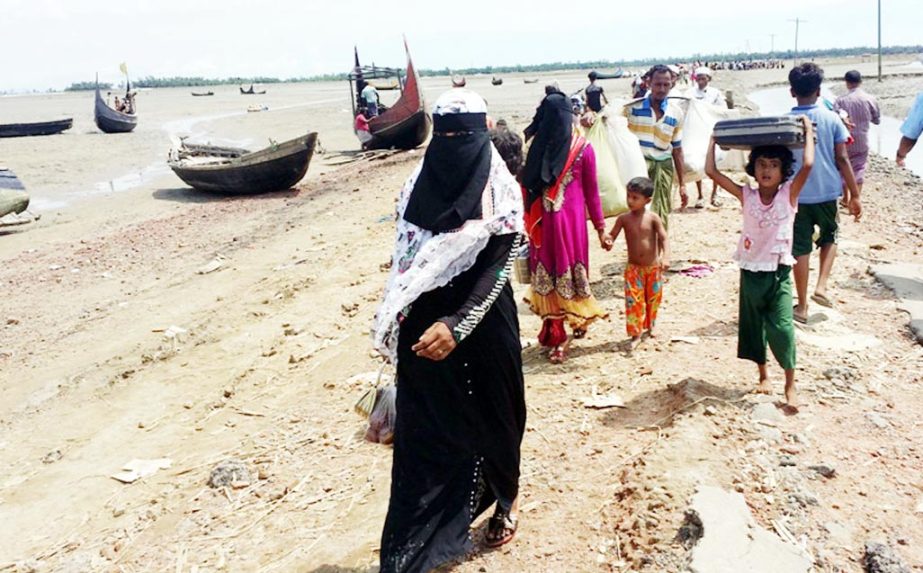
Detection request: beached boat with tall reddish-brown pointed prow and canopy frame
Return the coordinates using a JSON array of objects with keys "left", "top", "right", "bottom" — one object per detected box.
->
[{"left": 348, "top": 40, "right": 432, "bottom": 149}]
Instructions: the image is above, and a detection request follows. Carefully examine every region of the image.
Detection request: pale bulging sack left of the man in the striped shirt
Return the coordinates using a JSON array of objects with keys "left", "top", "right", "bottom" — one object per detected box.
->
[{"left": 582, "top": 104, "right": 647, "bottom": 217}]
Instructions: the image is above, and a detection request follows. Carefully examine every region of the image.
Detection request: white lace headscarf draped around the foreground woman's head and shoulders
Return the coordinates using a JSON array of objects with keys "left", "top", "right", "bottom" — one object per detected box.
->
[{"left": 372, "top": 88, "right": 523, "bottom": 365}]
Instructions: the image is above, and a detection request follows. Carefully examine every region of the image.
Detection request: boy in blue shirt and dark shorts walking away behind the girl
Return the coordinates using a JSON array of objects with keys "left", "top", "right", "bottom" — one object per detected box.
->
[{"left": 788, "top": 62, "right": 862, "bottom": 324}]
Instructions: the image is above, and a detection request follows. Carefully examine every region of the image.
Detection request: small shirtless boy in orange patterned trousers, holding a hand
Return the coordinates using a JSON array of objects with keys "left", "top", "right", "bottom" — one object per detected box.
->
[{"left": 606, "top": 177, "right": 670, "bottom": 349}]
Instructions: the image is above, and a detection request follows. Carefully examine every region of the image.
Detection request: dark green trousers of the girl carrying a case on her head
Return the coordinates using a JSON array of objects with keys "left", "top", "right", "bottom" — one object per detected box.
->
[{"left": 737, "top": 265, "right": 795, "bottom": 370}]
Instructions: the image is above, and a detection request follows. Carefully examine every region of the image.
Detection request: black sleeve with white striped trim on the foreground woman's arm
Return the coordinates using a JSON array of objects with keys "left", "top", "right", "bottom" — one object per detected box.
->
[{"left": 439, "top": 234, "right": 520, "bottom": 342}]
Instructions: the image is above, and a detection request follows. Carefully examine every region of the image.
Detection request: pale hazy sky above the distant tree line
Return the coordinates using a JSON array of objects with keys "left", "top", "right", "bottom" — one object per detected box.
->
[{"left": 0, "top": 0, "right": 923, "bottom": 91}]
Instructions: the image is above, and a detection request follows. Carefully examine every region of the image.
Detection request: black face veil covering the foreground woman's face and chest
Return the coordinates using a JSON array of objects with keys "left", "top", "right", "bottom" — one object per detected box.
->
[{"left": 404, "top": 113, "right": 492, "bottom": 233}]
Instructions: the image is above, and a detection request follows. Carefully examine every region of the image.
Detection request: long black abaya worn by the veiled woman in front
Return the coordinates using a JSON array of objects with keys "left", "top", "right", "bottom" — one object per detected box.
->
[{"left": 381, "top": 235, "right": 526, "bottom": 573}]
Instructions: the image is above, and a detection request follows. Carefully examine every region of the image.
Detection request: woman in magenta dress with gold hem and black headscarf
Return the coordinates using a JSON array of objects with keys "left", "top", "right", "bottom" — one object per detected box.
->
[{"left": 522, "top": 86, "right": 607, "bottom": 363}]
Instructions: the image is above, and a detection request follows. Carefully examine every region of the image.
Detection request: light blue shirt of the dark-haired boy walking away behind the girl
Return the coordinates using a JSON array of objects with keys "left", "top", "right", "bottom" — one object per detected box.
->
[{"left": 789, "top": 104, "right": 849, "bottom": 205}]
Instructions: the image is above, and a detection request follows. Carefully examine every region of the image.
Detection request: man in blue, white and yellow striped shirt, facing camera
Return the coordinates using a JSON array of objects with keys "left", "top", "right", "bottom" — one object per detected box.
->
[{"left": 622, "top": 65, "right": 689, "bottom": 227}]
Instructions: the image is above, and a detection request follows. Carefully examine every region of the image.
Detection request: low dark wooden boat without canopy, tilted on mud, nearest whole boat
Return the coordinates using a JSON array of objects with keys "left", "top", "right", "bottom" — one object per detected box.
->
[{"left": 168, "top": 132, "right": 317, "bottom": 195}]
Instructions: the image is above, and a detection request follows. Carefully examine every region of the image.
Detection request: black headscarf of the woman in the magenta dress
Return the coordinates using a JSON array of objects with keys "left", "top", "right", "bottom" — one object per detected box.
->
[{"left": 522, "top": 89, "right": 574, "bottom": 203}]
